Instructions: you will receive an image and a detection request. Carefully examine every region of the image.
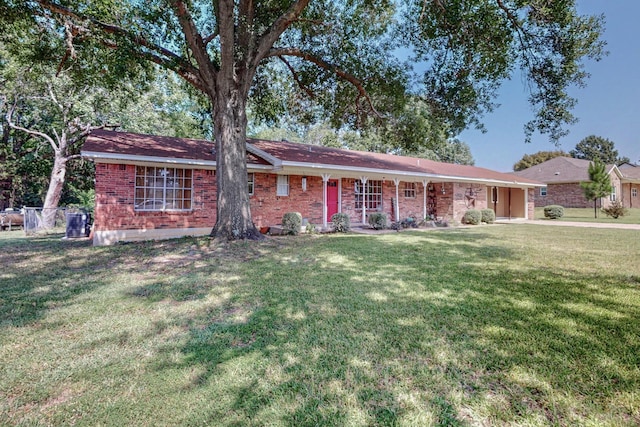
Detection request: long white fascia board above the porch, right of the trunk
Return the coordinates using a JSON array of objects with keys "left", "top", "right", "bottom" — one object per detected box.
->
[{"left": 282, "top": 161, "right": 546, "bottom": 188}]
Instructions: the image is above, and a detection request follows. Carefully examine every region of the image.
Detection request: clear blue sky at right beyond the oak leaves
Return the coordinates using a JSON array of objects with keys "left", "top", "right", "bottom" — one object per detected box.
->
[{"left": 459, "top": 0, "right": 640, "bottom": 171}]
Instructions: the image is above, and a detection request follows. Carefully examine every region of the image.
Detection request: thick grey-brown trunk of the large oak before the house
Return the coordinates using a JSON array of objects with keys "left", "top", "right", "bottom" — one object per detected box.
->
[{"left": 211, "top": 88, "right": 264, "bottom": 241}]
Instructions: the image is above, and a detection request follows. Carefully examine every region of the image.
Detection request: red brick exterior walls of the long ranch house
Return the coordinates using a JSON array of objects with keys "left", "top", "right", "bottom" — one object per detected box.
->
[{"left": 94, "top": 163, "right": 533, "bottom": 231}]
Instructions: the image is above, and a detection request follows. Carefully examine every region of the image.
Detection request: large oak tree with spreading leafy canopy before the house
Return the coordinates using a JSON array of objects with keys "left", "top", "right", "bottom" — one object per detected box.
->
[{"left": 0, "top": 0, "right": 602, "bottom": 239}]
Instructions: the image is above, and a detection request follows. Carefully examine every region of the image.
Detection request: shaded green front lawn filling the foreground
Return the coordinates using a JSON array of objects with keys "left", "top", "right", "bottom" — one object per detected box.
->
[{"left": 0, "top": 225, "right": 640, "bottom": 426}]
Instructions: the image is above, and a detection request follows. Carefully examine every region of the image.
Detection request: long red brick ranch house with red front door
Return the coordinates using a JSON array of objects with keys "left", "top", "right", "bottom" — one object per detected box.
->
[{"left": 82, "top": 130, "right": 542, "bottom": 245}]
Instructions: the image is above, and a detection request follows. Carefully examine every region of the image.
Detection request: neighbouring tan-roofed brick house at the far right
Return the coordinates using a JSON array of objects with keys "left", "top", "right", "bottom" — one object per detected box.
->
[{"left": 514, "top": 157, "right": 640, "bottom": 208}]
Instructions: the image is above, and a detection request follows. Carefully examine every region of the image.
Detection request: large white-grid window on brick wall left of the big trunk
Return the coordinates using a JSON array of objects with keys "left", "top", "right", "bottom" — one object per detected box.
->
[{"left": 134, "top": 166, "right": 193, "bottom": 211}]
